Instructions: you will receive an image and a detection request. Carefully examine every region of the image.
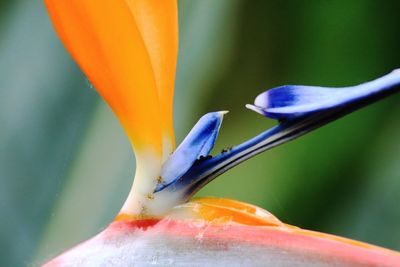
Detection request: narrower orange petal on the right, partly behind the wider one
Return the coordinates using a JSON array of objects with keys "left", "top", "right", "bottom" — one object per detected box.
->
[{"left": 127, "top": 0, "right": 178, "bottom": 156}]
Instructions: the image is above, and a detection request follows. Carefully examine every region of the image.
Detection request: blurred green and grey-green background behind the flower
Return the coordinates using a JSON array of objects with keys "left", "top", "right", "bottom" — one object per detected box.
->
[{"left": 0, "top": 0, "right": 400, "bottom": 266}]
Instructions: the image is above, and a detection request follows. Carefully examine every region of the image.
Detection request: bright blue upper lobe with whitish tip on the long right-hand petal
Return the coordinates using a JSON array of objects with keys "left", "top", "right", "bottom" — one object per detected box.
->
[{"left": 247, "top": 70, "right": 400, "bottom": 120}]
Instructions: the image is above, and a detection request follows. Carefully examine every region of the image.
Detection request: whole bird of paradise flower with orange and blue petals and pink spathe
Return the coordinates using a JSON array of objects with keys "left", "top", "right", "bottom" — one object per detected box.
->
[{"left": 41, "top": 0, "right": 400, "bottom": 266}]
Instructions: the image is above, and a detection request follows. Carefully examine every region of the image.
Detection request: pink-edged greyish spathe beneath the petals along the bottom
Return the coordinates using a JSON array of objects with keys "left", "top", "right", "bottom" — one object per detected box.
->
[{"left": 44, "top": 219, "right": 400, "bottom": 267}]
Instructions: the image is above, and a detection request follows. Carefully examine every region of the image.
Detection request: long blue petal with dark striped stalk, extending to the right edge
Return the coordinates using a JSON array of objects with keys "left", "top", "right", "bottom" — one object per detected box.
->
[{"left": 157, "top": 70, "right": 400, "bottom": 206}]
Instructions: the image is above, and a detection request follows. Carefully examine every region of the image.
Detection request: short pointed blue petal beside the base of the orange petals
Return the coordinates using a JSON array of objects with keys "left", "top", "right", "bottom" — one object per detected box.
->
[{"left": 155, "top": 111, "right": 227, "bottom": 192}]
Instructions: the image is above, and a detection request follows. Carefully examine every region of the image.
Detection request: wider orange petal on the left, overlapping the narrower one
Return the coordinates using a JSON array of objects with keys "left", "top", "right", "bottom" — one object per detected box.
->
[{"left": 45, "top": 0, "right": 176, "bottom": 155}]
